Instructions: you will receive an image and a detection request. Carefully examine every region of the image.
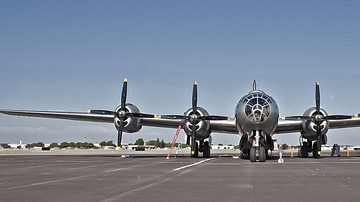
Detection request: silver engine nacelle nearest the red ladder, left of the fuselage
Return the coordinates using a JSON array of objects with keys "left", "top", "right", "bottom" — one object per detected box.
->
[{"left": 184, "top": 107, "right": 211, "bottom": 140}]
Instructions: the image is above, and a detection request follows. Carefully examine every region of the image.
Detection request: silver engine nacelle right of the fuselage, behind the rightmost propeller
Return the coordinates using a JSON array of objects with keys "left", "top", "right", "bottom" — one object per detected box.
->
[{"left": 301, "top": 107, "right": 329, "bottom": 141}]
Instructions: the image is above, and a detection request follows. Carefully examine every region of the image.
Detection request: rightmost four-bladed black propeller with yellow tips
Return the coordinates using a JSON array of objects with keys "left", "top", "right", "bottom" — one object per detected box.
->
[{"left": 285, "top": 82, "right": 353, "bottom": 157}]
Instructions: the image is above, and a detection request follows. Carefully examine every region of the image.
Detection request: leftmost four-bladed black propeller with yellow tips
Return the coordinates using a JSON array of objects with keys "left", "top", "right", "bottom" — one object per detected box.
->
[{"left": 88, "top": 79, "right": 157, "bottom": 148}]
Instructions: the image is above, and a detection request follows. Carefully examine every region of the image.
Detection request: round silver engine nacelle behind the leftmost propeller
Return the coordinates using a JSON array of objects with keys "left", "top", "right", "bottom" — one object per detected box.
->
[{"left": 114, "top": 103, "right": 142, "bottom": 133}]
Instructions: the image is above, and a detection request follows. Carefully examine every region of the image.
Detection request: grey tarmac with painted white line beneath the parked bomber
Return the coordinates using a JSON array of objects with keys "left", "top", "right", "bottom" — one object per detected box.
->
[{"left": 0, "top": 150, "right": 360, "bottom": 202}]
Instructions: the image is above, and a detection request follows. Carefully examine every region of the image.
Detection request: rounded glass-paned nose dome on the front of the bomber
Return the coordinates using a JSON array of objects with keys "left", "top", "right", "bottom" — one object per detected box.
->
[{"left": 245, "top": 93, "right": 270, "bottom": 122}]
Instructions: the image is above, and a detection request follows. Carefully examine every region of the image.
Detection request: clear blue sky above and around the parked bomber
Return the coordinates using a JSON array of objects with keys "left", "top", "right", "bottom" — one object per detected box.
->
[{"left": 0, "top": 0, "right": 360, "bottom": 144}]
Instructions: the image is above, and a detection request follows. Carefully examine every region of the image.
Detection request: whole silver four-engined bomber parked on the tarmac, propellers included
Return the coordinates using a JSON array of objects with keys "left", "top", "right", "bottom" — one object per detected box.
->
[{"left": 0, "top": 79, "right": 360, "bottom": 162}]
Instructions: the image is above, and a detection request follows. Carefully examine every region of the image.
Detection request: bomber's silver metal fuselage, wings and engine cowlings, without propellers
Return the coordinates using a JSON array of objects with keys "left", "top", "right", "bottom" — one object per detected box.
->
[{"left": 0, "top": 81, "right": 360, "bottom": 160}]
